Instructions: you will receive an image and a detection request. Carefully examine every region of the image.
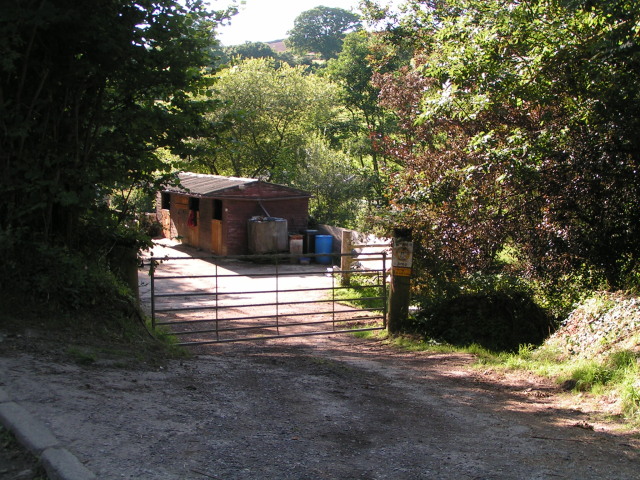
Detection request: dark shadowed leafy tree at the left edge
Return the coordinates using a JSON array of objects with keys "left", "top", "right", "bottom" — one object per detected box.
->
[{"left": 0, "top": 0, "right": 230, "bottom": 304}]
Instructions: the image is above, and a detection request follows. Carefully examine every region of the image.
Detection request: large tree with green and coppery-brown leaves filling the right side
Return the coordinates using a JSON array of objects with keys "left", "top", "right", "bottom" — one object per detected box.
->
[{"left": 378, "top": 0, "right": 640, "bottom": 304}]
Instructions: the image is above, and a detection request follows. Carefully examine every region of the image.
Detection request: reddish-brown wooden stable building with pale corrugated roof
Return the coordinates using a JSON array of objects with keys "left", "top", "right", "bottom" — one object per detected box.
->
[{"left": 156, "top": 173, "right": 311, "bottom": 255}]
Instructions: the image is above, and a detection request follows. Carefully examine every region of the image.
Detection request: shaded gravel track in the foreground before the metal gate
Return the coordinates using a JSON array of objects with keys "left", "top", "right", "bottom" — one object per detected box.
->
[{"left": 0, "top": 242, "right": 640, "bottom": 480}]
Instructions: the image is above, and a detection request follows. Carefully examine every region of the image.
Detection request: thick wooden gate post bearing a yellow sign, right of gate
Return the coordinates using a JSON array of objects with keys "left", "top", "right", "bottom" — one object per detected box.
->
[{"left": 387, "top": 228, "right": 413, "bottom": 333}]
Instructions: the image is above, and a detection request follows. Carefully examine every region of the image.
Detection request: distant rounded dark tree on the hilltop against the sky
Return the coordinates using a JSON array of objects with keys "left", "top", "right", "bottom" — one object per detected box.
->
[{"left": 285, "top": 7, "right": 362, "bottom": 60}]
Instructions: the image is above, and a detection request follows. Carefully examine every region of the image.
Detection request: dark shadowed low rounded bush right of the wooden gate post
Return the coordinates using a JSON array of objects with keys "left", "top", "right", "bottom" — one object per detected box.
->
[{"left": 417, "top": 292, "right": 553, "bottom": 351}]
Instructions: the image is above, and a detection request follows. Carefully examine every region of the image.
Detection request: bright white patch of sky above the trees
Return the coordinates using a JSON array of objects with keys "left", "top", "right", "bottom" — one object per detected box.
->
[{"left": 210, "top": 0, "right": 359, "bottom": 46}]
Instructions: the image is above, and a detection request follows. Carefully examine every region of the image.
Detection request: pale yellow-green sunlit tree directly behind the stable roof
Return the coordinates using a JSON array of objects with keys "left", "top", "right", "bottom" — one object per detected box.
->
[{"left": 192, "top": 59, "right": 336, "bottom": 183}]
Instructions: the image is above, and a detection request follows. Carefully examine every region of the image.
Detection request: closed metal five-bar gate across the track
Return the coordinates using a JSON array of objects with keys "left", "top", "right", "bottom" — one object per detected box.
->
[{"left": 148, "top": 252, "right": 387, "bottom": 346}]
